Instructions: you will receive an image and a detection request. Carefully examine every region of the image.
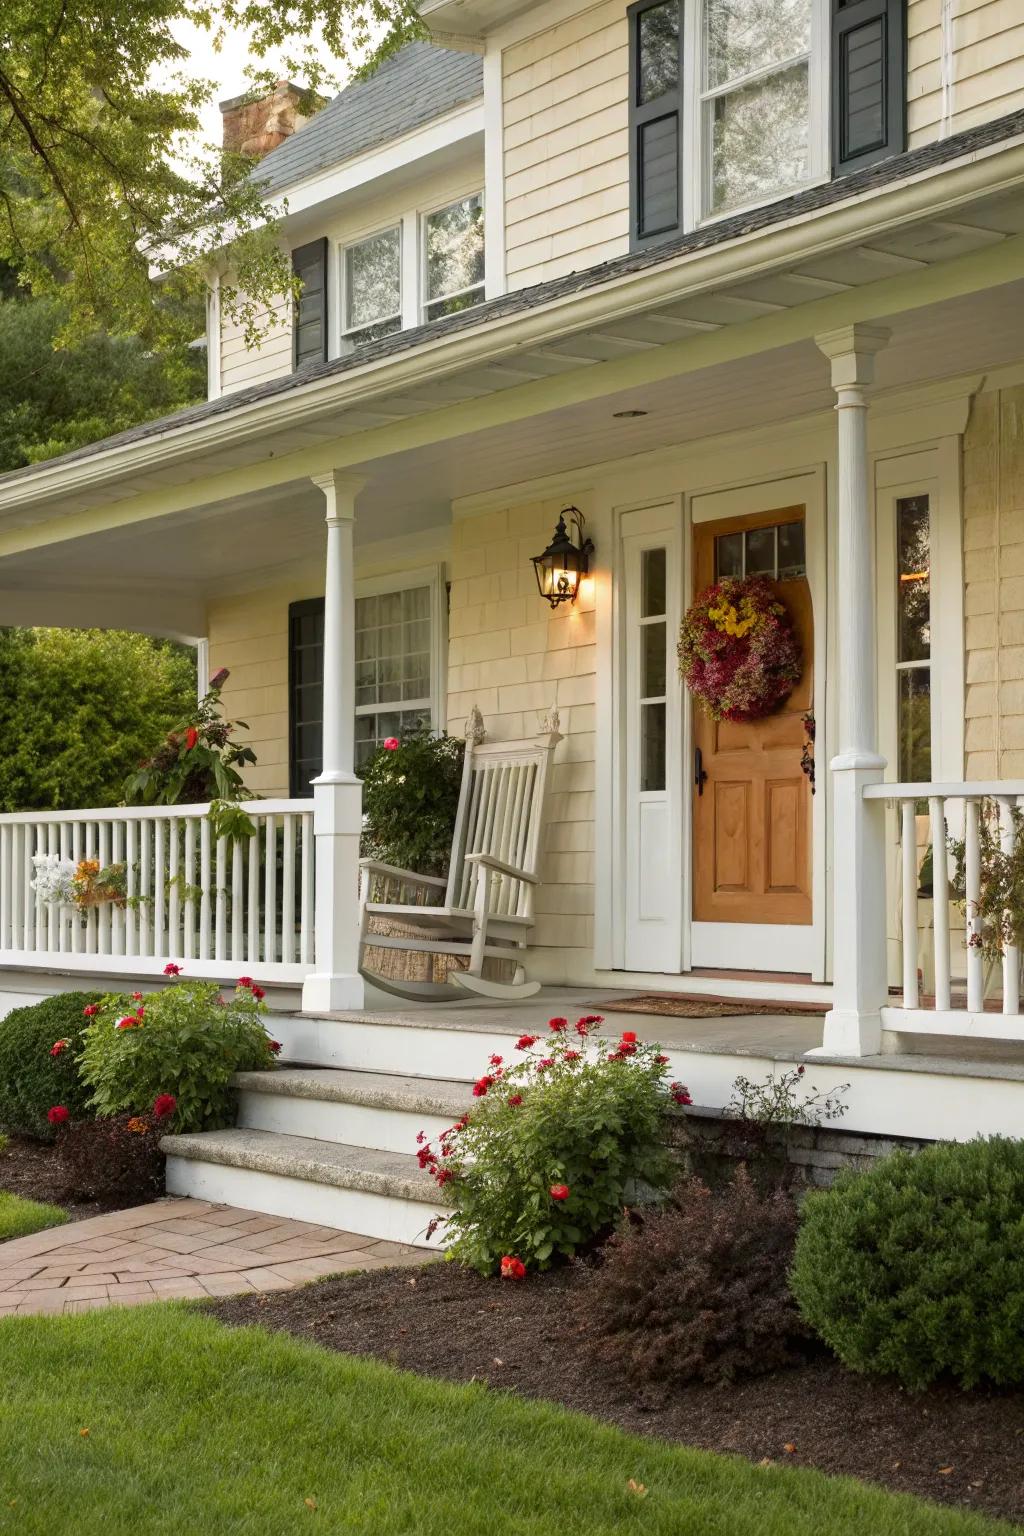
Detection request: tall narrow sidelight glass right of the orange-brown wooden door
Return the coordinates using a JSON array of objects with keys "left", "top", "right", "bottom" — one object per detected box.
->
[{"left": 897, "top": 496, "right": 932, "bottom": 783}]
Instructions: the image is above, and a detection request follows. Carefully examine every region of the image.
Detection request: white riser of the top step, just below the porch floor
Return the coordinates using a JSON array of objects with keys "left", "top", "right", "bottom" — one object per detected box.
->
[{"left": 275, "top": 1017, "right": 520, "bottom": 1083}]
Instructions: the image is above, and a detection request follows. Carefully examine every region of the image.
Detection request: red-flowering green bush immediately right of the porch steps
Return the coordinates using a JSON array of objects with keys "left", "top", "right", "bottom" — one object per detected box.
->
[{"left": 419, "top": 1015, "right": 691, "bottom": 1278}]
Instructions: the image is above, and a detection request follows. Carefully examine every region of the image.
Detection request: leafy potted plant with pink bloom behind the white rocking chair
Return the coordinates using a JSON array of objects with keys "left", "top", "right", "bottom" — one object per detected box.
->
[{"left": 361, "top": 733, "right": 465, "bottom": 874}]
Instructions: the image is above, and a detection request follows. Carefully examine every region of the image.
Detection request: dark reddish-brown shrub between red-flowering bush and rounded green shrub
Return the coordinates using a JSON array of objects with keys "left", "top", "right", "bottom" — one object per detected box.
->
[{"left": 577, "top": 1166, "right": 811, "bottom": 1390}]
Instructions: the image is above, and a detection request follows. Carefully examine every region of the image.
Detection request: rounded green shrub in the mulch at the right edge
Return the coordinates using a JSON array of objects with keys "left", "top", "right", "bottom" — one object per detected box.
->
[{"left": 791, "top": 1137, "right": 1024, "bottom": 1389}]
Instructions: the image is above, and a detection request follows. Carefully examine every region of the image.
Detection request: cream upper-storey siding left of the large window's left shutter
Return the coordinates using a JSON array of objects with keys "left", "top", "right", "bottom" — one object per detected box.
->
[{"left": 502, "top": 0, "right": 629, "bottom": 289}]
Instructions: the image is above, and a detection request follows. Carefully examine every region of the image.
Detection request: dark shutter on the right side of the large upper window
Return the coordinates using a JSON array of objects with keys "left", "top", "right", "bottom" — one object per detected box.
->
[{"left": 831, "top": 0, "right": 907, "bottom": 177}]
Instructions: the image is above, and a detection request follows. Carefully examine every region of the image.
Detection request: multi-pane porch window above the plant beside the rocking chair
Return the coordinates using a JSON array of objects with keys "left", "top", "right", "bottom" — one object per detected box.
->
[{"left": 356, "top": 587, "right": 431, "bottom": 766}]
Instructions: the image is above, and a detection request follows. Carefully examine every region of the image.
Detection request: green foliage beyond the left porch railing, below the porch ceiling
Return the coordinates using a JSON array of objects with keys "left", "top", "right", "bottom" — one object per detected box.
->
[{"left": 0, "top": 630, "right": 195, "bottom": 811}]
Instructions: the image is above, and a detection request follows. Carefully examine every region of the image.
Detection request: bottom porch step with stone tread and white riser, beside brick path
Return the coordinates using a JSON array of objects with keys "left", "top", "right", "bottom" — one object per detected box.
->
[{"left": 161, "top": 1127, "right": 445, "bottom": 1247}]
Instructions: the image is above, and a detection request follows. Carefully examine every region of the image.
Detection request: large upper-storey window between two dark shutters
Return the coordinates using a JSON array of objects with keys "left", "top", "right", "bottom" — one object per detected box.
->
[{"left": 702, "top": 0, "right": 812, "bottom": 214}]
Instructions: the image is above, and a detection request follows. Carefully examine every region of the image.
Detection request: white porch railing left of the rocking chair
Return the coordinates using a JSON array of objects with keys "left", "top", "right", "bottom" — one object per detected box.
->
[{"left": 0, "top": 800, "right": 315, "bottom": 982}]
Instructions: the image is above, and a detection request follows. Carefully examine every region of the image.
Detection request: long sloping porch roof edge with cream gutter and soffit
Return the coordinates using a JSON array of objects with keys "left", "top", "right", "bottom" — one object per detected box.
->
[{"left": 0, "top": 112, "right": 1024, "bottom": 534}]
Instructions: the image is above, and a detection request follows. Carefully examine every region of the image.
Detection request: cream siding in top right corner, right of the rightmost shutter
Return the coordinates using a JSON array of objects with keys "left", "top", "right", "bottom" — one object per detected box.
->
[{"left": 907, "top": 0, "right": 1024, "bottom": 147}]
